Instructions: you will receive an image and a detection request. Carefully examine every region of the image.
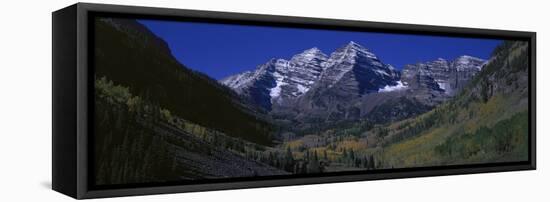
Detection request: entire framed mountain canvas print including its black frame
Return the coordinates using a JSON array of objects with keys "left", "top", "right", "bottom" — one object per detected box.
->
[{"left": 52, "top": 3, "right": 536, "bottom": 198}]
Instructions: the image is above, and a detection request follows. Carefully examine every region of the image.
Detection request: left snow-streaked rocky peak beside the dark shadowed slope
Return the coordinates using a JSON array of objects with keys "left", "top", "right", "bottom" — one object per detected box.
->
[{"left": 220, "top": 48, "right": 328, "bottom": 109}]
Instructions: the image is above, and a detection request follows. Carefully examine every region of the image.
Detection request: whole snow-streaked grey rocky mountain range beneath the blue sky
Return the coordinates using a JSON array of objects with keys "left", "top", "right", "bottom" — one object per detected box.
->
[{"left": 220, "top": 41, "right": 487, "bottom": 128}]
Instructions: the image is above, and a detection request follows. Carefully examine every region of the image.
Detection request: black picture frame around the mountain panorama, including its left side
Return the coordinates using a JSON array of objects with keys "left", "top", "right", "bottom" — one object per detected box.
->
[{"left": 52, "top": 3, "right": 536, "bottom": 199}]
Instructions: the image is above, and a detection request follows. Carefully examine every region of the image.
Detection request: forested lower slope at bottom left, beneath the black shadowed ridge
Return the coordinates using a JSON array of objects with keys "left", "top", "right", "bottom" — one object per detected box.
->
[{"left": 94, "top": 77, "right": 288, "bottom": 185}]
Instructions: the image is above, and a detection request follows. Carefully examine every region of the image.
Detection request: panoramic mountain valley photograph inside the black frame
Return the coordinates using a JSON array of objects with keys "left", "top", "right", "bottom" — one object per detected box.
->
[{"left": 92, "top": 17, "right": 529, "bottom": 185}]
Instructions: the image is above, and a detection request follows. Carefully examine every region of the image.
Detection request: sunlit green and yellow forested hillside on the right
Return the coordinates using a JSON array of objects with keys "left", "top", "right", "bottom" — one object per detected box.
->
[{"left": 362, "top": 42, "right": 529, "bottom": 167}]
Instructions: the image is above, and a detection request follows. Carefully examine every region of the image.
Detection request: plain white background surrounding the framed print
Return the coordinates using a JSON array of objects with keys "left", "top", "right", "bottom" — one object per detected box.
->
[{"left": 0, "top": 0, "right": 550, "bottom": 202}]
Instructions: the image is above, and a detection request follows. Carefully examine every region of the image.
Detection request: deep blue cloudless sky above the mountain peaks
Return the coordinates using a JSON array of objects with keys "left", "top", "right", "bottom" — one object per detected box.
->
[{"left": 139, "top": 20, "right": 501, "bottom": 79}]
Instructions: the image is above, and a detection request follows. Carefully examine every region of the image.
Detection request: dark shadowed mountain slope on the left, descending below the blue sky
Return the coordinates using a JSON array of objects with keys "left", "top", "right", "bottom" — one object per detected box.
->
[{"left": 95, "top": 19, "right": 271, "bottom": 145}]
